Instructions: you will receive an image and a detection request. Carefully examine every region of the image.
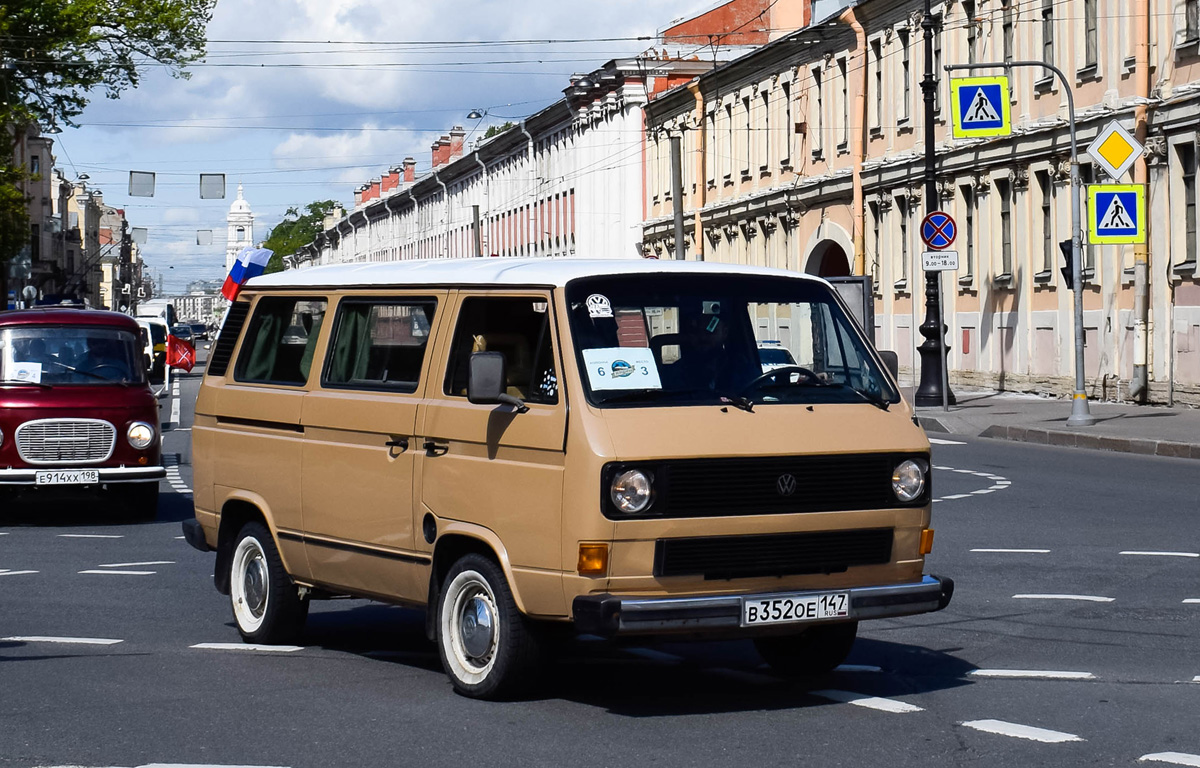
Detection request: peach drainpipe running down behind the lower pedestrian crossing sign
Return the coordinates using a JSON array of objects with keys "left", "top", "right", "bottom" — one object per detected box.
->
[{"left": 1129, "top": 0, "right": 1152, "bottom": 403}]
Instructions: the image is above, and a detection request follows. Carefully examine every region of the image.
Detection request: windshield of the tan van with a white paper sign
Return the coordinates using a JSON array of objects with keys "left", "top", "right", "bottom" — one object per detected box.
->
[{"left": 566, "top": 275, "right": 900, "bottom": 408}]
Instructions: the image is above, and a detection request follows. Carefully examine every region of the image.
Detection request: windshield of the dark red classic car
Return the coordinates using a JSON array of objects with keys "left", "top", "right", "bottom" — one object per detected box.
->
[{"left": 0, "top": 325, "right": 145, "bottom": 386}]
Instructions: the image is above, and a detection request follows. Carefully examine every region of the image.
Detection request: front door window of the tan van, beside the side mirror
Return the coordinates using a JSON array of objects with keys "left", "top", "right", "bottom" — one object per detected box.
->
[{"left": 445, "top": 296, "right": 558, "bottom": 404}]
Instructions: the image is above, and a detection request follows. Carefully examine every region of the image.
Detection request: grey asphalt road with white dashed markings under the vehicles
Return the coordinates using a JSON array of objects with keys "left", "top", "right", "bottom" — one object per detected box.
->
[{"left": 0, "top": 362, "right": 1200, "bottom": 768}]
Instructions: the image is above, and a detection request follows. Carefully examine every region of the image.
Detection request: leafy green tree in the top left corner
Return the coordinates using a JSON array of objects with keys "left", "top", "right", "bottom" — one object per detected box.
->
[{"left": 0, "top": 0, "right": 216, "bottom": 298}]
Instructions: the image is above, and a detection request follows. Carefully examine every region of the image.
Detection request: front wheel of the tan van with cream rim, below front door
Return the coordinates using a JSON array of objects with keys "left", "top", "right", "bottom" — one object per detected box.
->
[{"left": 437, "top": 554, "right": 538, "bottom": 700}]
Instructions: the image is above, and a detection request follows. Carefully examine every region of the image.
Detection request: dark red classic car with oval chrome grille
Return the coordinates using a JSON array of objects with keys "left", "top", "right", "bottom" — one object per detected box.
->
[{"left": 0, "top": 308, "right": 166, "bottom": 518}]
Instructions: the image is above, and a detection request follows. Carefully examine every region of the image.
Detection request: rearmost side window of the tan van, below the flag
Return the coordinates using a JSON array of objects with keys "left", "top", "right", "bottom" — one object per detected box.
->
[{"left": 234, "top": 296, "right": 325, "bottom": 385}]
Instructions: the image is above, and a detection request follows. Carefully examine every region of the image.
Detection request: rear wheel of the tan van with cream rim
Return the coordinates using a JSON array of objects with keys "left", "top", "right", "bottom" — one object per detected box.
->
[{"left": 229, "top": 522, "right": 308, "bottom": 644}]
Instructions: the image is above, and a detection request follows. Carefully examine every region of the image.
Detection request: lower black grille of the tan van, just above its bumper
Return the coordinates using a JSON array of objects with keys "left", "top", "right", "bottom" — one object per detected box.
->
[{"left": 654, "top": 528, "right": 893, "bottom": 578}]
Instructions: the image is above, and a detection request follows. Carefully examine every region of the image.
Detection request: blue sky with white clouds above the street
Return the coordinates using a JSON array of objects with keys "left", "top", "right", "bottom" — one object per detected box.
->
[{"left": 55, "top": 0, "right": 707, "bottom": 293}]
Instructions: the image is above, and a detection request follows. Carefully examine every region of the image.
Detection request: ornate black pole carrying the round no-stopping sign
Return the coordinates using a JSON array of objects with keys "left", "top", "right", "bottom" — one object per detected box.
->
[{"left": 913, "top": 0, "right": 955, "bottom": 406}]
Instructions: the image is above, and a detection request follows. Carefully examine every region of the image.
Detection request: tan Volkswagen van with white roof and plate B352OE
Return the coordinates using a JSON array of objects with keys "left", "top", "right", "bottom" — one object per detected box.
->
[{"left": 184, "top": 259, "right": 953, "bottom": 697}]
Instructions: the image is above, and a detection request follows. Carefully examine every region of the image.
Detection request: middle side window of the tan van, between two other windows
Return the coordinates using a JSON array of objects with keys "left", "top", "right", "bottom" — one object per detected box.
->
[{"left": 322, "top": 299, "right": 437, "bottom": 392}]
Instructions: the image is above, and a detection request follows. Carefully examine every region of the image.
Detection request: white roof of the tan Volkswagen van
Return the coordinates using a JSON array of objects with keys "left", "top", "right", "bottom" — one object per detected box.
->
[{"left": 246, "top": 258, "right": 823, "bottom": 288}]
